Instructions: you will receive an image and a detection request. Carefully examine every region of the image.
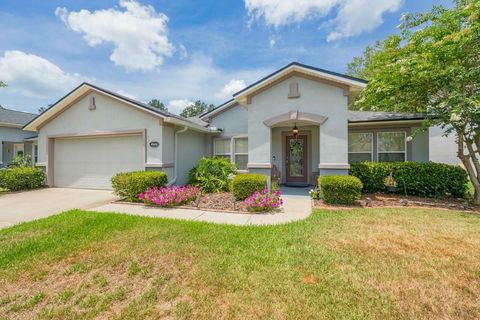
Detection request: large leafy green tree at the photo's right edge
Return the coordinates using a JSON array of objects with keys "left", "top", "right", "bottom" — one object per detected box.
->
[{"left": 348, "top": 0, "right": 480, "bottom": 204}]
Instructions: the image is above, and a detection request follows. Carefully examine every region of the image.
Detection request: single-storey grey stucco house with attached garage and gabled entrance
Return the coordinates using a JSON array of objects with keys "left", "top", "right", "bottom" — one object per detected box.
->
[{"left": 24, "top": 63, "right": 429, "bottom": 189}]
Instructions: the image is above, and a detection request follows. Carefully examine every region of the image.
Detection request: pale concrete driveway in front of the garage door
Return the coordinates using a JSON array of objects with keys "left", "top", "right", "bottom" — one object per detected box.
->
[{"left": 0, "top": 188, "right": 116, "bottom": 228}]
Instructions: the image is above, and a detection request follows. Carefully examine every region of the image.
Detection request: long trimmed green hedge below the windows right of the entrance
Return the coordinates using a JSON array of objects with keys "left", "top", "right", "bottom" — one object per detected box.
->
[{"left": 350, "top": 162, "right": 468, "bottom": 198}]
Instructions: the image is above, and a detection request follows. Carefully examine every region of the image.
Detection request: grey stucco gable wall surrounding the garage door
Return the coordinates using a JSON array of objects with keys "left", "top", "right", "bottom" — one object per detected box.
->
[{"left": 38, "top": 93, "right": 163, "bottom": 163}]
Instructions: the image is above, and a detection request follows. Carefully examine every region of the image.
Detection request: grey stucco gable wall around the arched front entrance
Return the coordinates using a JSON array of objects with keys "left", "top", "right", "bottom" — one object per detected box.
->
[{"left": 248, "top": 76, "right": 348, "bottom": 172}]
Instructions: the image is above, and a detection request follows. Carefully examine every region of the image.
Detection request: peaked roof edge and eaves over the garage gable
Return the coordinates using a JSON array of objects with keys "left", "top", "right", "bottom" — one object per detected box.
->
[{"left": 24, "top": 82, "right": 216, "bottom": 132}]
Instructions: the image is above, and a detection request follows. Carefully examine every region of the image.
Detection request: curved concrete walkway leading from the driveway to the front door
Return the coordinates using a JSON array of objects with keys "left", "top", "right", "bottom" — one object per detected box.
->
[{"left": 90, "top": 188, "right": 312, "bottom": 226}]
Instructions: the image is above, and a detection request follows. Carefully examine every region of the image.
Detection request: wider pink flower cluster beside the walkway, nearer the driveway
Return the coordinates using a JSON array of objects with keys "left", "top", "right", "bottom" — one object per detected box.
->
[{"left": 138, "top": 186, "right": 200, "bottom": 207}]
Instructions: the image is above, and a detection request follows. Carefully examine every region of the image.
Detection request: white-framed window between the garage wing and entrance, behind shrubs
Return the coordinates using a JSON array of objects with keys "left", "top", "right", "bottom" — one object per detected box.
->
[{"left": 213, "top": 137, "right": 248, "bottom": 170}]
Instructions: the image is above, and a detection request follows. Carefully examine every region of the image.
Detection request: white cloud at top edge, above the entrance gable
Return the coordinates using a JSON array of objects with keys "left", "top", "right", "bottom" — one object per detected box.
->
[{"left": 245, "top": 0, "right": 403, "bottom": 41}]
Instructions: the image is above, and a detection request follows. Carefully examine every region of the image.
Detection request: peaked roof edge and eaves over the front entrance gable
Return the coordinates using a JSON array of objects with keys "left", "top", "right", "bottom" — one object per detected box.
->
[{"left": 233, "top": 62, "right": 368, "bottom": 105}]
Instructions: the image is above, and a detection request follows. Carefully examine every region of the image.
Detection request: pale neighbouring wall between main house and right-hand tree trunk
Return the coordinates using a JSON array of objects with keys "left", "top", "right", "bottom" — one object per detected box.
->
[{"left": 429, "top": 127, "right": 461, "bottom": 165}]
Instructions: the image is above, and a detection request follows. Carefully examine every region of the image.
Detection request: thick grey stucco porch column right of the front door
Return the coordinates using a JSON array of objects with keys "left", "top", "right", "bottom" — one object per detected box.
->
[{"left": 318, "top": 117, "right": 350, "bottom": 176}]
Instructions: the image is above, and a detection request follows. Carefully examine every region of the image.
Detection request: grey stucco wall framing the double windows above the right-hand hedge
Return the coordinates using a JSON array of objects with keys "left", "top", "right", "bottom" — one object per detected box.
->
[{"left": 348, "top": 123, "right": 429, "bottom": 162}]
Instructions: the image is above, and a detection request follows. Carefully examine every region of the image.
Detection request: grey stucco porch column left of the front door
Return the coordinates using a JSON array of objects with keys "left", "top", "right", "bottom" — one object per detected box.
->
[{"left": 247, "top": 118, "right": 272, "bottom": 188}]
